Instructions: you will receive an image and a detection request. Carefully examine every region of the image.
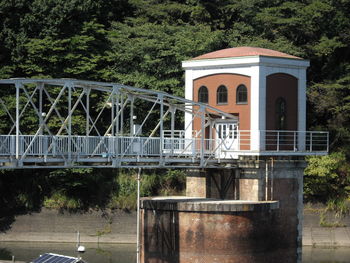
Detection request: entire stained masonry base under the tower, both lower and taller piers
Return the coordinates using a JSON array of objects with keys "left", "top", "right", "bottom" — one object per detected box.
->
[{"left": 141, "top": 159, "right": 305, "bottom": 263}]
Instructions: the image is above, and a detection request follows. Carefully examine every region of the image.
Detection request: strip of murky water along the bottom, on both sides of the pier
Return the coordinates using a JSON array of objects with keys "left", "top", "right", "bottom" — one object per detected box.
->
[{"left": 0, "top": 242, "right": 350, "bottom": 263}]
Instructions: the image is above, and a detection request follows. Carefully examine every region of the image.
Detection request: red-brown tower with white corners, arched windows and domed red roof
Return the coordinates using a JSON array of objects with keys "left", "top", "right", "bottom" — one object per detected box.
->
[{"left": 182, "top": 47, "right": 309, "bottom": 157}]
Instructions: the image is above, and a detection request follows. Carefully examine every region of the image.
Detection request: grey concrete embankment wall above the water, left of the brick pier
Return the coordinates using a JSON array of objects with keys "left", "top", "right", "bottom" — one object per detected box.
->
[{"left": 0, "top": 208, "right": 136, "bottom": 243}]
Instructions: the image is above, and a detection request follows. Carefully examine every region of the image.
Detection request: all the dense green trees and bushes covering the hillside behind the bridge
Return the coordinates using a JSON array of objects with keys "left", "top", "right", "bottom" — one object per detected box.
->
[{"left": 0, "top": 0, "right": 350, "bottom": 215}]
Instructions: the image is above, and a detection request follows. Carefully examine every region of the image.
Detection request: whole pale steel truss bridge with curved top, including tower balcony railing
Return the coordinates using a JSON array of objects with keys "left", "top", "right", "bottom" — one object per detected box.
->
[{"left": 0, "top": 79, "right": 329, "bottom": 168}]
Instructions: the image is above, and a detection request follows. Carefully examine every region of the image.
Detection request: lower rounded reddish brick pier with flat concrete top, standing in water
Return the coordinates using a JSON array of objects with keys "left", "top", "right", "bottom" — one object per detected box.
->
[{"left": 141, "top": 197, "right": 278, "bottom": 263}]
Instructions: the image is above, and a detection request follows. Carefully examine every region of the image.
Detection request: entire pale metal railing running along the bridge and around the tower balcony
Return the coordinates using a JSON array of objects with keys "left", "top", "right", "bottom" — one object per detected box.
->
[{"left": 0, "top": 131, "right": 329, "bottom": 158}]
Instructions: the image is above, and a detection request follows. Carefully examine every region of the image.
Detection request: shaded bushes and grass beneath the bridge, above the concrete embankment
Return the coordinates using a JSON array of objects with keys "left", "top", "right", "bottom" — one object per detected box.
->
[{"left": 0, "top": 169, "right": 185, "bottom": 215}]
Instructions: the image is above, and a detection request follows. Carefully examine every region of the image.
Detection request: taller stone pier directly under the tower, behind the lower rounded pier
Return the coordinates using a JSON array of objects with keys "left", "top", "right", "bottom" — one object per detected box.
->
[{"left": 187, "top": 159, "right": 306, "bottom": 262}]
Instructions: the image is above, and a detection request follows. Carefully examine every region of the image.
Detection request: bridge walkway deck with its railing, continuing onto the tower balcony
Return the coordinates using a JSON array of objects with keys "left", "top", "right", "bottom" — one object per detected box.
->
[{"left": 0, "top": 131, "right": 327, "bottom": 168}]
